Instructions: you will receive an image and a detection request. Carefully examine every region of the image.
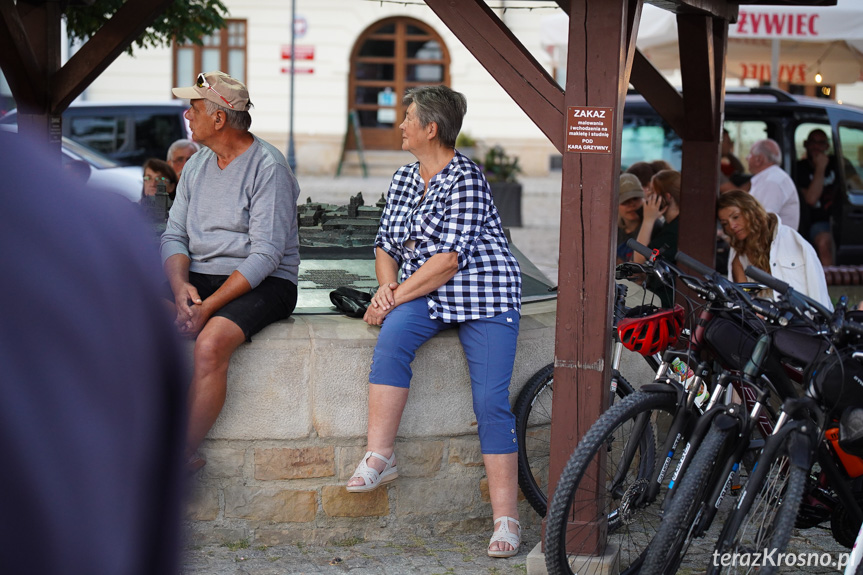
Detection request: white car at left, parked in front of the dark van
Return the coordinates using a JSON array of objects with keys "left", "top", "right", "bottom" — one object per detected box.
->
[{"left": 0, "top": 124, "right": 144, "bottom": 202}]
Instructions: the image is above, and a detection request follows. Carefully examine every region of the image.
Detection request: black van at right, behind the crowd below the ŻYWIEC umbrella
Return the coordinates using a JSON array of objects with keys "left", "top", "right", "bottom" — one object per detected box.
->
[{"left": 621, "top": 88, "right": 863, "bottom": 264}]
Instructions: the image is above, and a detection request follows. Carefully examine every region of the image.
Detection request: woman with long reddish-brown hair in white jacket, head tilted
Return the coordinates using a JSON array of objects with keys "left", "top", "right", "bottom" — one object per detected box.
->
[{"left": 716, "top": 190, "right": 833, "bottom": 309}]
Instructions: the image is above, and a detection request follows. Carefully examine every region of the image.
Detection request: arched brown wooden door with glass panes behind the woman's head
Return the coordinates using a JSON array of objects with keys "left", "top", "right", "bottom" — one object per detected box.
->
[{"left": 348, "top": 18, "right": 449, "bottom": 150}]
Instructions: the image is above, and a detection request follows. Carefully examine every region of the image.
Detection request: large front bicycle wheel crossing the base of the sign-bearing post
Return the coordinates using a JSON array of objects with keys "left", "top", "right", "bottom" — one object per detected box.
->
[{"left": 545, "top": 388, "right": 677, "bottom": 575}]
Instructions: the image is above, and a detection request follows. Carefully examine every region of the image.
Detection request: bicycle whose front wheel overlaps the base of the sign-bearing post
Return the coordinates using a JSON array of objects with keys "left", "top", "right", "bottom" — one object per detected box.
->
[{"left": 545, "top": 242, "right": 782, "bottom": 574}]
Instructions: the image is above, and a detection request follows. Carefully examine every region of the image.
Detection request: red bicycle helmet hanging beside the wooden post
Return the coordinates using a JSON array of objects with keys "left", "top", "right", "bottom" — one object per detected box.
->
[{"left": 617, "top": 305, "right": 686, "bottom": 355}]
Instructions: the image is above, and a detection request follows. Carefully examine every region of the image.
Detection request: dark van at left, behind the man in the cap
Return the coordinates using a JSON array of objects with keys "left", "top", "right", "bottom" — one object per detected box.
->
[{"left": 0, "top": 100, "right": 189, "bottom": 166}]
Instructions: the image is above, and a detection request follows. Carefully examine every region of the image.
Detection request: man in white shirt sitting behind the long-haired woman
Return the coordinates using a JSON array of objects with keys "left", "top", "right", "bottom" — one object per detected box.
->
[{"left": 746, "top": 139, "right": 800, "bottom": 230}]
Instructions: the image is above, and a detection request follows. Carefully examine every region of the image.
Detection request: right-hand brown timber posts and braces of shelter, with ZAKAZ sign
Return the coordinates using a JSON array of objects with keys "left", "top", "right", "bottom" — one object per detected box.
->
[{"left": 425, "top": 0, "right": 836, "bottom": 551}]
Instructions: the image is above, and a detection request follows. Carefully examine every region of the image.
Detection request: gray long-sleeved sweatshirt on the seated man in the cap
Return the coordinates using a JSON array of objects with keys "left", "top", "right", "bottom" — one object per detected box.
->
[{"left": 161, "top": 136, "right": 300, "bottom": 288}]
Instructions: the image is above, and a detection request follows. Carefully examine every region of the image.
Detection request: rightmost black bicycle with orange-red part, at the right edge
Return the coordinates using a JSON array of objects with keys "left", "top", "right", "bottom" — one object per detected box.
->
[{"left": 708, "top": 268, "right": 863, "bottom": 573}]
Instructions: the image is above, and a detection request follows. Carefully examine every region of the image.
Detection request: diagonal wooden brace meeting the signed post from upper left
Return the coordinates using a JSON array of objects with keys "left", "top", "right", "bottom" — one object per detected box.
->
[{"left": 424, "top": 0, "right": 564, "bottom": 153}]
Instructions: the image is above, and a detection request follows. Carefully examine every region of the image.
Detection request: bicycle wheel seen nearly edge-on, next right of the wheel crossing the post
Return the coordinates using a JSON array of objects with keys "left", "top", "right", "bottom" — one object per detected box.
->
[{"left": 640, "top": 425, "right": 730, "bottom": 575}]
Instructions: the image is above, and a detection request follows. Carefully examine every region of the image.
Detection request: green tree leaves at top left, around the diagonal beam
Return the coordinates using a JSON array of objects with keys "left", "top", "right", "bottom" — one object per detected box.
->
[{"left": 65, "top": 0, "right": 229, "bottom": 54}]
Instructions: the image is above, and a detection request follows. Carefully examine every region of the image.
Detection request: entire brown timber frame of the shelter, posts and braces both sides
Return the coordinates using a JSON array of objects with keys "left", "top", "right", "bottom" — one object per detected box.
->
[{"left": 0, "top": 0, "right": 836, "bottom": 548}]
